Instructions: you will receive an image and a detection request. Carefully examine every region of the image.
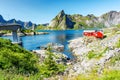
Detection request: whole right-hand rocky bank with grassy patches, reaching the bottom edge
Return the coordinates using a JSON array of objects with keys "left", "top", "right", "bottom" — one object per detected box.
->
[{"left": 45, "top": 27, "right": 120, "bottom": 80}]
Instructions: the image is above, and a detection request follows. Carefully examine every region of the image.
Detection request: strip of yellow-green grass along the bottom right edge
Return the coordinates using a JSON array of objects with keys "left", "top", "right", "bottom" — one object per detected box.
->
[{"left": 65, "top": 70, "right": 120, "bottom": 80}]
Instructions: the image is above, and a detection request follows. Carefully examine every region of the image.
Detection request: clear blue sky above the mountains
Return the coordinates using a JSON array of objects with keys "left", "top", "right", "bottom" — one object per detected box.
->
[{"left": 0, "top": 0, "right": 120, "bottom": 24}]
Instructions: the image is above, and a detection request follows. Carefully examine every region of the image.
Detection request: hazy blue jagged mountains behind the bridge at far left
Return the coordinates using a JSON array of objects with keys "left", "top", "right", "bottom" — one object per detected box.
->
[{"left": 0, "top": 15, "right": 36, "bottom": 29}]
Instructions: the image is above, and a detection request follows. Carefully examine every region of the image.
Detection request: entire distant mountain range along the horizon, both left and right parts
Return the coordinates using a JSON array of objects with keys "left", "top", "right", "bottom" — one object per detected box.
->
[{"left": 0, "top": 10, "right": 120, "bottom": 30}]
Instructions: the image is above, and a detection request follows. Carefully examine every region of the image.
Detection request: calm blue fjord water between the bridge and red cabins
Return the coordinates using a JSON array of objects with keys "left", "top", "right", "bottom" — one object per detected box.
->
[{"left": 3, "top": 30, "right": 83, "bottom": 58}]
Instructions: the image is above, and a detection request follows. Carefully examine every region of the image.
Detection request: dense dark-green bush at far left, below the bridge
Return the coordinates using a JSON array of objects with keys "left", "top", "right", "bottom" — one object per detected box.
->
[{"left": 0, "top": 38, "right": 37, "bottom": 74}]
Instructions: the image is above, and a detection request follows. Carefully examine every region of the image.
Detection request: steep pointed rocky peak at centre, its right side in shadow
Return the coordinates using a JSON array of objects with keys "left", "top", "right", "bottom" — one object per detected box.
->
[{"left": 49, "top": 10, "right": 74, "bottom": 30}]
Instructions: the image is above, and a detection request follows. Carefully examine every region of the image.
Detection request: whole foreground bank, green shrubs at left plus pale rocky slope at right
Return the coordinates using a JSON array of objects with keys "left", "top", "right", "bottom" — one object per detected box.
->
[{"left": 0, "top": 26, "right": 120, "bottom": 80}]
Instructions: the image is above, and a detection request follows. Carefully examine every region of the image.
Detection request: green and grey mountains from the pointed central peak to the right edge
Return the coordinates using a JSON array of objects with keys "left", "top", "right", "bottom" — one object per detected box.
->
[{"left": 49, "top": 10, "right": 120, "bottom": 30}]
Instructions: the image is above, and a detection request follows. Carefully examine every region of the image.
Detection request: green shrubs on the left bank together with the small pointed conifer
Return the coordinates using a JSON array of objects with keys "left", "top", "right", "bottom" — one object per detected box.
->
[{"left": 0, "top": 38, "right": 66, "bottom": 80}]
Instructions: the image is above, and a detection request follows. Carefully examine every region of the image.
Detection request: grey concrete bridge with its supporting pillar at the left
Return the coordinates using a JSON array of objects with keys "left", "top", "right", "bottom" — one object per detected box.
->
[{"left": 0, "top": 24, "right": 21, "bottom": 44}]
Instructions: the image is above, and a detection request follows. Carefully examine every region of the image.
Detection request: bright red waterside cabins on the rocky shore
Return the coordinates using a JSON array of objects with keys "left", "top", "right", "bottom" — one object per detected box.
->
[{"left": 83, "top": 30, "right": 104, "bottom": 38}]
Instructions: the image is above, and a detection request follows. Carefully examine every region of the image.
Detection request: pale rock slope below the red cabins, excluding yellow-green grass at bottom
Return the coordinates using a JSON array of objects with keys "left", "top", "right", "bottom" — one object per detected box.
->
[{"left": 66, "top": 28, "right": 120, "bottom": 77}]
